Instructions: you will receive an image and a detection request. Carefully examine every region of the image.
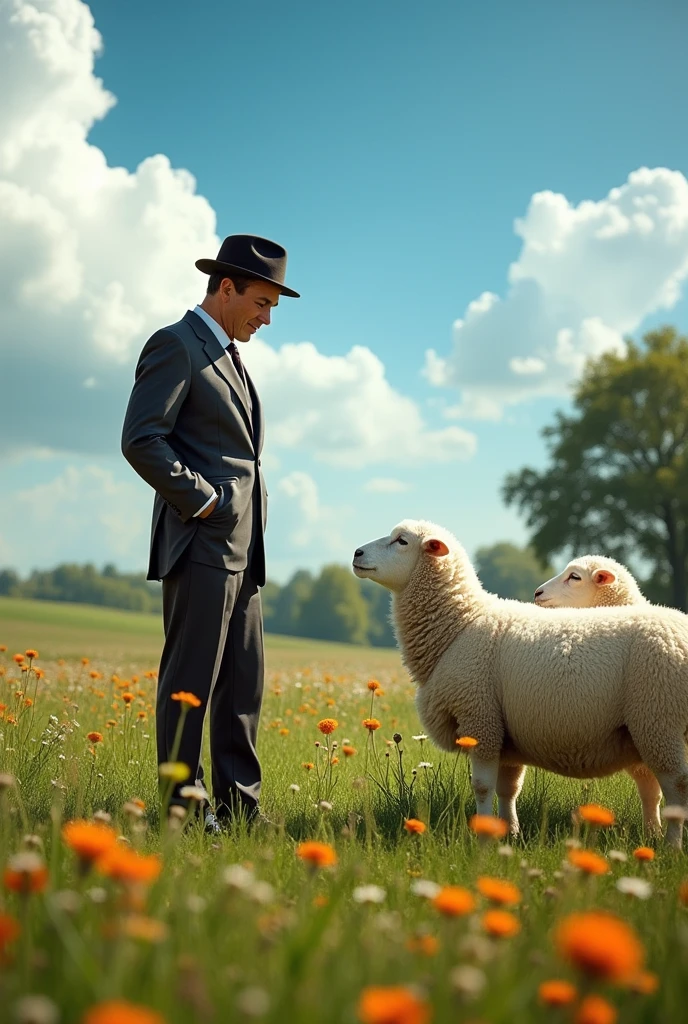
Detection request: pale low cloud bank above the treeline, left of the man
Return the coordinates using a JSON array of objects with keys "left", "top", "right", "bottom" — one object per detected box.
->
[{"left": 0, "top": 465, "right": 152, "bottom": 572}]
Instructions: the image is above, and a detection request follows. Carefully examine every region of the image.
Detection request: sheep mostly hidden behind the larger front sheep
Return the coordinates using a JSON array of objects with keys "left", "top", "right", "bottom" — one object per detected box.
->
[{"left": 534, "top": 555, "right": 661, "bottom": 835}]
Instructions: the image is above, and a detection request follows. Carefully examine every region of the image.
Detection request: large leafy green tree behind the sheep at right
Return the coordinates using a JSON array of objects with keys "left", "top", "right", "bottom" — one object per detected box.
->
[{"left": 504, "top": 327, "right": 688, "bottom": 610}]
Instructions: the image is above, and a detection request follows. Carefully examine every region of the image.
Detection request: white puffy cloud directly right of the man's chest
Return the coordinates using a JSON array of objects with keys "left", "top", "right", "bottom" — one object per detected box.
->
[{"left": 246, "top": 338, "right": 476, "bottom": 467}]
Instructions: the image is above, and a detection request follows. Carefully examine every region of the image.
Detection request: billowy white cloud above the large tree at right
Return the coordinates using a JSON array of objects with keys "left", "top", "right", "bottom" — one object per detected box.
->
[{"left": 424, "top": 168, "right": 688, "bottom": 420}]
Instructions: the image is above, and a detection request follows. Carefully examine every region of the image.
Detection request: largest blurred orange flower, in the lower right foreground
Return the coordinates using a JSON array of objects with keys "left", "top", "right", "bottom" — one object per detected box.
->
[{"left": 554, "top": 910, "right": 644, "bottom": 984}]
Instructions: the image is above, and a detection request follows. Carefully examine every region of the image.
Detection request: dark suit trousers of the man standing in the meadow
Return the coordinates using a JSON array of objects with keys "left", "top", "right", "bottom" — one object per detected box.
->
[{"left": 156, "top": 551, "right": 264, "bottom": 818}]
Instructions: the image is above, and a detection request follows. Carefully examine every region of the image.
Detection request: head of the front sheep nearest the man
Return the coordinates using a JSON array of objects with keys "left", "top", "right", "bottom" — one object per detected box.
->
[{"left": 352, "top": 519, "right": 450, "bottom": 593}]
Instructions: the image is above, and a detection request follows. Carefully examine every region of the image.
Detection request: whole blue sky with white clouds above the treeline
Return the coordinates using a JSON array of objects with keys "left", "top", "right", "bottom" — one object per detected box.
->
[{"left": 0, "top": 0, "right": 688, "bottom": 582}]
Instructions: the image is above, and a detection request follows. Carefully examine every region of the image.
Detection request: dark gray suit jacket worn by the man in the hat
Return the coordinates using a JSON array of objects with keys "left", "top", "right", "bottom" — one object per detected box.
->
[{"left": 122, "top": 310, "right": 267, "bottom": 586}]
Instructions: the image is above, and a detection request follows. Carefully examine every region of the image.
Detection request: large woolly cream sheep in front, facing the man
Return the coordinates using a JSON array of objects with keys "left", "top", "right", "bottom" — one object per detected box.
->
[{"left": 353, "top": 519, "right": 688, "bottom": 848}]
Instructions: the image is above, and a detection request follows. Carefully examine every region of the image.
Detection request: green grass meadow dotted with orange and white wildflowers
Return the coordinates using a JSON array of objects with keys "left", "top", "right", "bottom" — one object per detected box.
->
[{"left": 0, "top": 599, "right": 688, "bottom": 1024}]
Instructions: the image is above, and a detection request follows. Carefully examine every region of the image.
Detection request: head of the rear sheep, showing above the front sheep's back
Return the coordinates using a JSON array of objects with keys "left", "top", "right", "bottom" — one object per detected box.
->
[{"left": 534, "top": 555, "right": 635, "bottom": 608}]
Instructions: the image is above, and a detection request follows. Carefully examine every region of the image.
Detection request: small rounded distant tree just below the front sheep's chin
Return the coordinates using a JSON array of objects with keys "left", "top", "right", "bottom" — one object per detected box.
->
[{"left": 299, "top": 565, "right": 369, "bottom": 644}]
